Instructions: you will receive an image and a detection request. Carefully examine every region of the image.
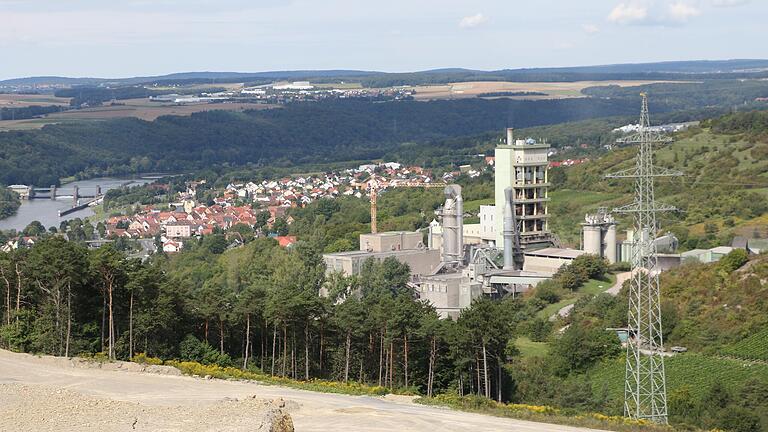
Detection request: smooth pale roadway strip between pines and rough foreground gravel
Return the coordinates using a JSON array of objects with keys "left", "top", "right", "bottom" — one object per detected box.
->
[{"left": 0, "top": 350, "right": 608, "bottom": 432}]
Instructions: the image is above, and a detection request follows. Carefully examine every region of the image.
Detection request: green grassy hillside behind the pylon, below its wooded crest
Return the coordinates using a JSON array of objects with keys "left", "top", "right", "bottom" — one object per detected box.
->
[{"left": 550, "top": 125, "right": 768, "bottom": 246}]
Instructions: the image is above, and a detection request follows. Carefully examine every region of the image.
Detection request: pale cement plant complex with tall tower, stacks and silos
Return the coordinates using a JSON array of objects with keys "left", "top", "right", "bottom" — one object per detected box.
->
[{"left": 323, "top": 128, "right": 618, "bottom": 318}]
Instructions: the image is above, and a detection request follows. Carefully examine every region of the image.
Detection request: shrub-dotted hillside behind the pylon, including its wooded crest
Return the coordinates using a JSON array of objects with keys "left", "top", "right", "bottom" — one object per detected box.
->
[{"left": 551, "top": 111, "right": 768, "bottom": 249}]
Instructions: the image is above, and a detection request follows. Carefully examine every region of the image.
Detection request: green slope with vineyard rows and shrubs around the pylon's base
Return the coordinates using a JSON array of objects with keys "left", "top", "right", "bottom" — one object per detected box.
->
[{"left": 588, "top": 255, "right": 768, "bottom": 420}]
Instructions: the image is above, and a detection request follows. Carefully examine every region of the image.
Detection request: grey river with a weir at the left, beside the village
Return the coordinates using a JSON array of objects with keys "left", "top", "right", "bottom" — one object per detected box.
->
[{"left": 0, "top": 176, "right": 157, "bottom": 231}]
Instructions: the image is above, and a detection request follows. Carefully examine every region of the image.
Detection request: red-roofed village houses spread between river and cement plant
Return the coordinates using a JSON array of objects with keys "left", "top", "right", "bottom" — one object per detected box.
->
[{"left": 100, "top": 162, "right": 450, "bottom": 253}]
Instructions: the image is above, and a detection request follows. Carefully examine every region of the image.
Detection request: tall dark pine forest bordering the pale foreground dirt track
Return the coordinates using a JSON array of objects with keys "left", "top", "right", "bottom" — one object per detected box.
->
[{"left": 0, "top": 235, "right": 618, "bottom": 400}]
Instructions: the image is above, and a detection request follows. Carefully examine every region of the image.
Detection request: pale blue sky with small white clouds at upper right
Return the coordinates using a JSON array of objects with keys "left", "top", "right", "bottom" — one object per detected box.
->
[{"left": 0, "top": 0, "right": 768, "bottom": 79}]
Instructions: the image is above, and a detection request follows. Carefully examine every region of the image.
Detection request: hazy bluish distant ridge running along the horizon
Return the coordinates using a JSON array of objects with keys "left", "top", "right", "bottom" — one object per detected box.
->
[{"left": 6, "top": 59, "right": 768, "bottom": 86}]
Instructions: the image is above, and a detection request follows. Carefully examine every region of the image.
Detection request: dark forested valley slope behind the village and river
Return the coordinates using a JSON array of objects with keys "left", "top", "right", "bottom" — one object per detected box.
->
[{"left": 0, "top": 99, "right": 637, "bottom": 184}]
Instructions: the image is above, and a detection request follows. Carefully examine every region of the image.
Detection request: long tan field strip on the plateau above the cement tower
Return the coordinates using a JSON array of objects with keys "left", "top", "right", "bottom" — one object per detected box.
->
[{"left": 414, "top": 80, "right": 692, "bottom": 100}]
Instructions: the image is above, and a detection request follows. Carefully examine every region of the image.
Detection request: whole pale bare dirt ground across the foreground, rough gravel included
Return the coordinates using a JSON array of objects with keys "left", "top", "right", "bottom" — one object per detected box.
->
[{"left": 0, "top": 350, "right": 604, "bottom": 432}]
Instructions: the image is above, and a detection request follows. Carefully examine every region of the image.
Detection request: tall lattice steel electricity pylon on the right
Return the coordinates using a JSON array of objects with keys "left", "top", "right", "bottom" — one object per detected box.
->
[{"left": 606, "top": 93, "right": 681, "bottom": 424}]
